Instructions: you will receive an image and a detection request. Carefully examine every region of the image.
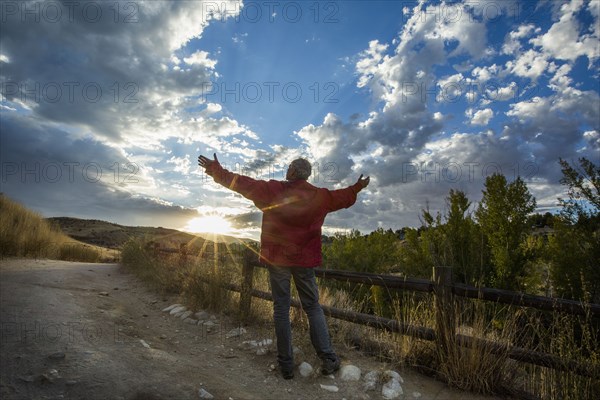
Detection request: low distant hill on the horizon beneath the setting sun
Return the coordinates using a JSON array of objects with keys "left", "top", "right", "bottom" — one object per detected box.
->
[{"left": 48, "top": 217, "right": 248, "bottom": 249}]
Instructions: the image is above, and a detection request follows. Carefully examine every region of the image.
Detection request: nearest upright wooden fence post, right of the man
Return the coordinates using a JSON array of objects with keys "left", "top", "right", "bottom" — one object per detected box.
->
[{"left": 433, "top": 267, "right": 456, "bottom": 364}]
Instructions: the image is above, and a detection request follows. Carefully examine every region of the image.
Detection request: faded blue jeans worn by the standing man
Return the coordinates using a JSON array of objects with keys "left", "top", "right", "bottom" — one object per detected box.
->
[{"left": 269, "top": 265, "right": 337, "bottom": 371}]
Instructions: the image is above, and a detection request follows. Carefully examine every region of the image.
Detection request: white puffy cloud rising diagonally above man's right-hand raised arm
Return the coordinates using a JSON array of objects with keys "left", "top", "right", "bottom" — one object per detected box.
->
[{"left": 296, "top": 4, "right": 486, "bottom": 189}]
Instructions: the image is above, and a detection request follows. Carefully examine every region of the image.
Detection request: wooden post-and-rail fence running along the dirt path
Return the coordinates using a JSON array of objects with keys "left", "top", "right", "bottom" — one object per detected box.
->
[{"left": 157, "top": 245, "right": 600, "bottom": 377}]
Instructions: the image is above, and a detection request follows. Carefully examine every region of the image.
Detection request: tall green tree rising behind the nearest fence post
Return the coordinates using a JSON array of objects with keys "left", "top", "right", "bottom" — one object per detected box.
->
[{"left": 475, "top": 174, "right": 536, "bottom": 289}]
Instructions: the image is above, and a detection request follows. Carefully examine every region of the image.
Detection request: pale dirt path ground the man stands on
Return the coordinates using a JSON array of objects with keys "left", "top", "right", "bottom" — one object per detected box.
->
[{"left": 0, "top": 259, "right": 510, "bottom": 400}]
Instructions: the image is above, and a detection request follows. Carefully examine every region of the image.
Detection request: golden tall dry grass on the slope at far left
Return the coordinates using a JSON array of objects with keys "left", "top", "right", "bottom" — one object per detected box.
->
[{"left": 0, "top": 195, "right": 101, "bottom": 262}]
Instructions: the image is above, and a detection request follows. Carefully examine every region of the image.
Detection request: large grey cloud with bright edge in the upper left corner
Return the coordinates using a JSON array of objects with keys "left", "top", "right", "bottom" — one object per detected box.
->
[{"left": 0, "top": 1, "right": 244, "bottom": 146}]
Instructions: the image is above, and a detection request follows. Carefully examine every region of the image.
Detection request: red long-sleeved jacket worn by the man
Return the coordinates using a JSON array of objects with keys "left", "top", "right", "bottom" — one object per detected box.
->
[{"left": 206, "top": 163, "right": 361, "bottom": 268}]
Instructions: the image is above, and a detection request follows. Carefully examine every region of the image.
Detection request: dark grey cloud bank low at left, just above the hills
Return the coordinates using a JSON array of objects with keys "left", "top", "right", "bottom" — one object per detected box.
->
[{"left": 1, "top": 115, "right": 196, "bottom": 226}]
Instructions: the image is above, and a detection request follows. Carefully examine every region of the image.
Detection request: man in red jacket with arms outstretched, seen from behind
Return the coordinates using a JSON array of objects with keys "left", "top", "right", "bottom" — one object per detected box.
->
[{"left": 198, "top": 154, "right": 370, "bottom": 379}]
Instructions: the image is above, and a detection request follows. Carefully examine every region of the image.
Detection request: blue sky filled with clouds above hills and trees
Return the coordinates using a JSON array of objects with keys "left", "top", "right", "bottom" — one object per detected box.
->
[{"left": 0, "top": 0, "right": 600, "bottom": 238}]
